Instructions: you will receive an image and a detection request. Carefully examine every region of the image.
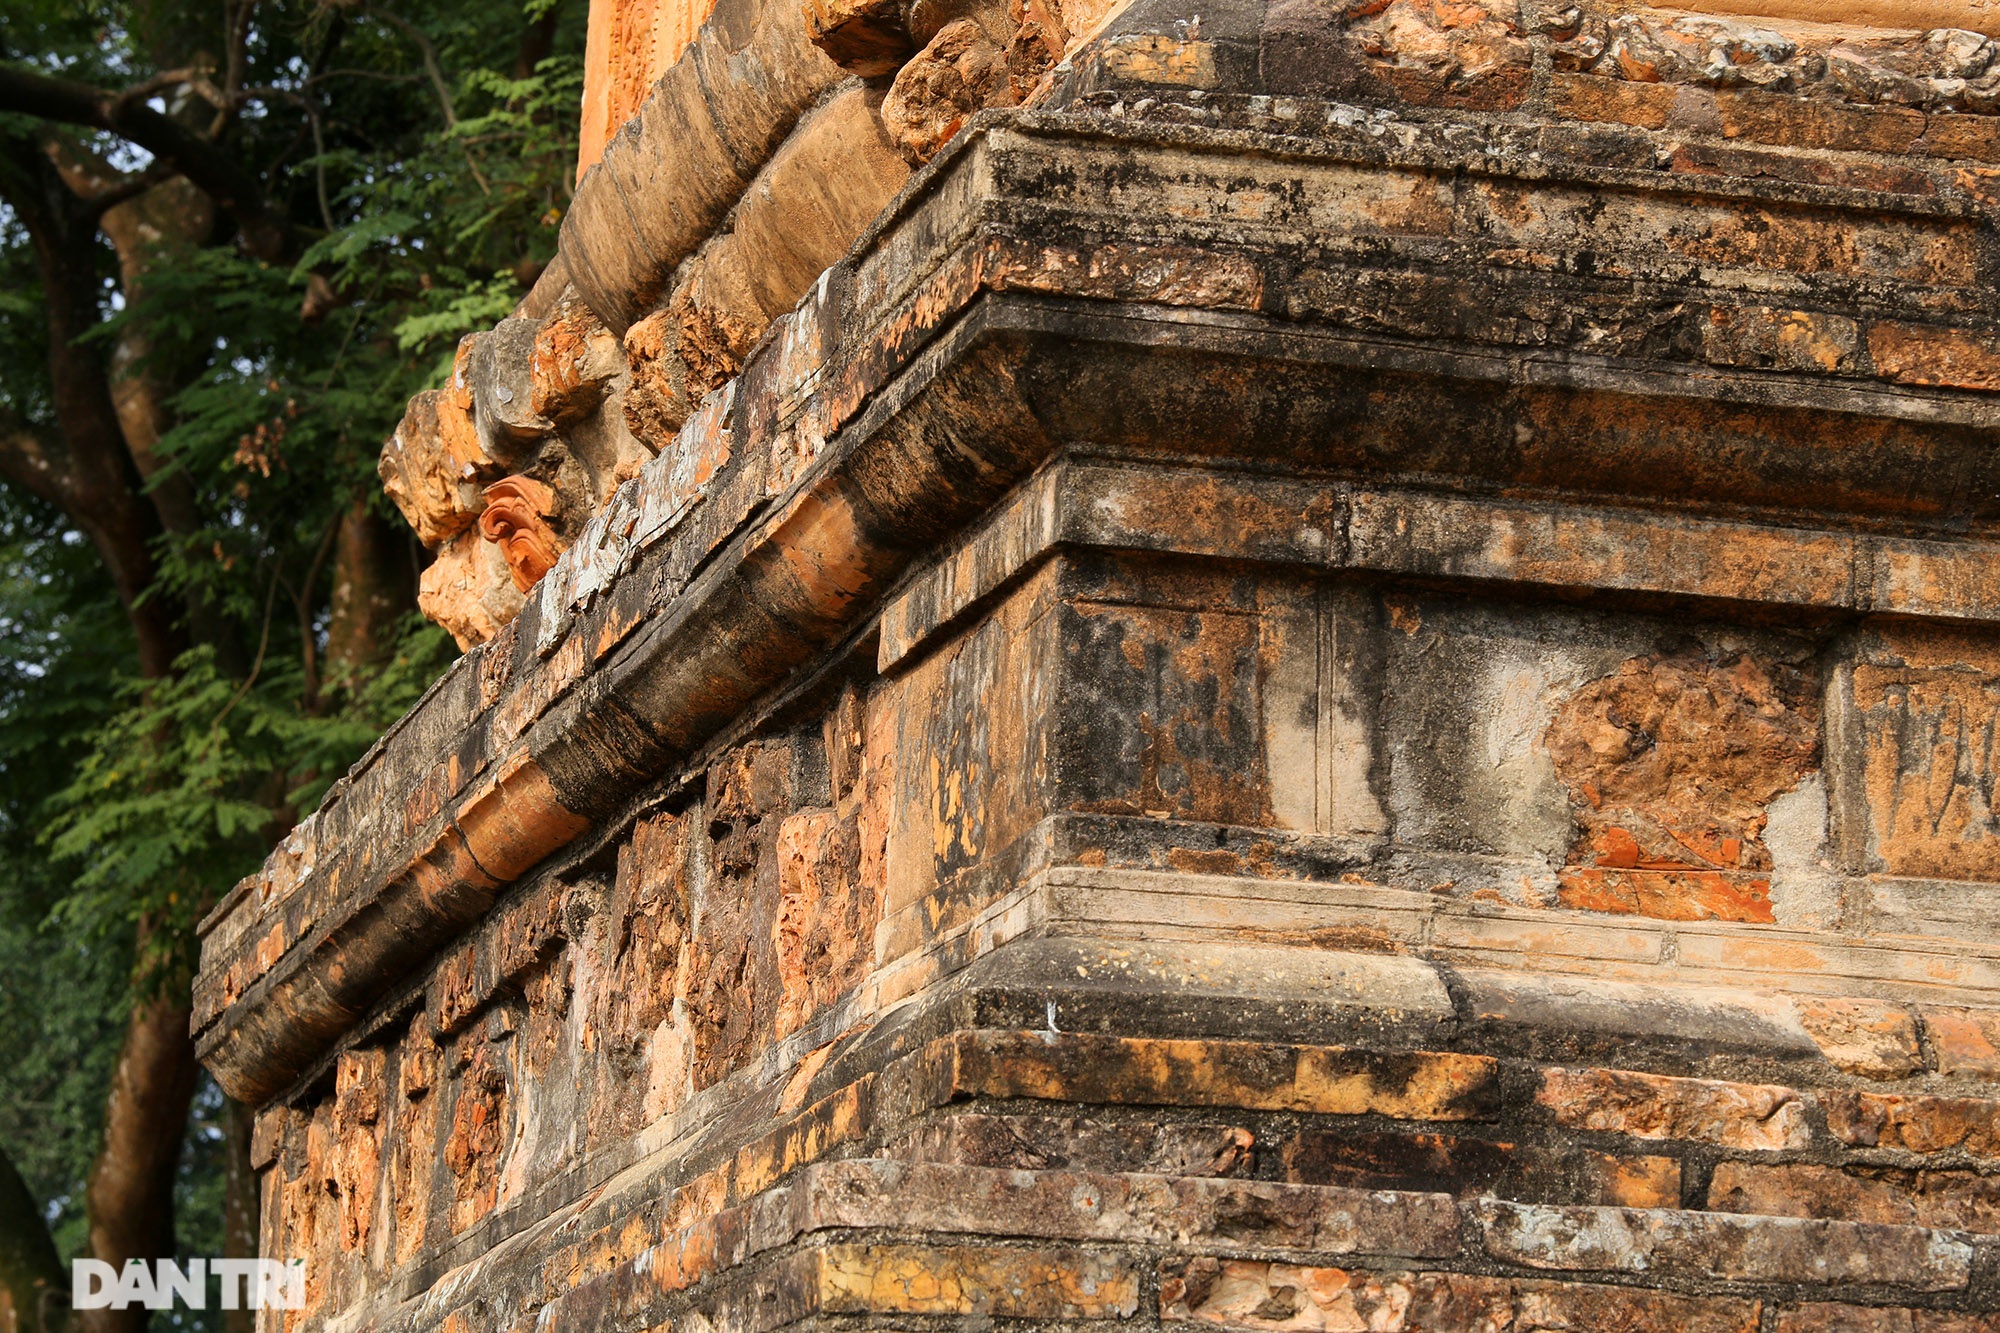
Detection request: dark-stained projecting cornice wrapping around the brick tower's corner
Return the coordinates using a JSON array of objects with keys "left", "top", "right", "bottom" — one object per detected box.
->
[{"left": 198, "top": 101, "right": 2000, "bottom": 1091}]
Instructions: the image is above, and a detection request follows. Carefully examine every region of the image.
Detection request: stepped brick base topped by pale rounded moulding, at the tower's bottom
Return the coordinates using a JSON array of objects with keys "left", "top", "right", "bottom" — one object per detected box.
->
[{"left": 266, "top": 937, "right": 2000, "bottom": 1331}]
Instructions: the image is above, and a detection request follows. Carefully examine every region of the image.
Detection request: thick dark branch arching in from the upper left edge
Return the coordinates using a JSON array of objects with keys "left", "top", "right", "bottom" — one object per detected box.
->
[{"left": 0, "top": 66, "right": 290, "bottom": 258}]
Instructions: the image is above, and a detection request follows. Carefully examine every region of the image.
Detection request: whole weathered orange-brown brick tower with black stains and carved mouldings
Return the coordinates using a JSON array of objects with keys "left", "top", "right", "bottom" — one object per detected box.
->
[{"left": 196, "top": 0, "right": 2000, "bottom": 1333}]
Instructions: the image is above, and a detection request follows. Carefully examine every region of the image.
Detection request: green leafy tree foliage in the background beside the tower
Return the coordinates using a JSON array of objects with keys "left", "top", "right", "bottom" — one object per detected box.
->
[{"left": 0, "top": 0, "right": 584, "bottom": 1296}]
